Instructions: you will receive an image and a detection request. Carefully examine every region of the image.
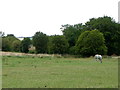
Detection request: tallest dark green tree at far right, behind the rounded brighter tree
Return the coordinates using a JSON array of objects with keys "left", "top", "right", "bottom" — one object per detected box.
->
[{"left": 85, "top": 16, "right": 120, "bottom": 55}]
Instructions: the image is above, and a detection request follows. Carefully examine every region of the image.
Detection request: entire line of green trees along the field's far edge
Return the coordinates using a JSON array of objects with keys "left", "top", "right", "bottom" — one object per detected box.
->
[{"left": 1, "top": 16, "right": 120, "bottom": 56}]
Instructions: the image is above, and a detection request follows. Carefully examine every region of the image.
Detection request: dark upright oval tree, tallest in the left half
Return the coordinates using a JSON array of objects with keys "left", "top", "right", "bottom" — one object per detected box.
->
[{"left": 33, "top": 32, "right": 48, "bottom": 53}]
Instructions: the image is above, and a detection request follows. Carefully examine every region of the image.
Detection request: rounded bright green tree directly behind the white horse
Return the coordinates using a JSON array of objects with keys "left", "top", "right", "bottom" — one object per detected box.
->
[{"left": 76, "top": 30, "right": 107, "bottom": 56}]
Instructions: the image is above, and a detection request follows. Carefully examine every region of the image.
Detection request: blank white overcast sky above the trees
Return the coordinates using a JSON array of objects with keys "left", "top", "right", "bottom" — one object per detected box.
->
[{"left": 0, "top": 0, "right": 119, "bottom": 37}]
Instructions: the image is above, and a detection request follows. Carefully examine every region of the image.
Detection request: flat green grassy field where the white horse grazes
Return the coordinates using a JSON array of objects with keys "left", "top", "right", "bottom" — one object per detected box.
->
[{"left": 2, "top": 56, "right": 118, "bottom": 88}]
